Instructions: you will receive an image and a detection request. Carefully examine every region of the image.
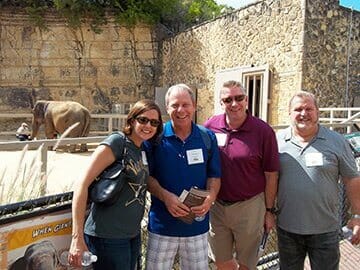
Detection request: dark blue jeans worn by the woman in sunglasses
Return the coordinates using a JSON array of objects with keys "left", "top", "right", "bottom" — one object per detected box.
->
[{"left": 85, "top": 234, "right": 141, "bottom": 270}]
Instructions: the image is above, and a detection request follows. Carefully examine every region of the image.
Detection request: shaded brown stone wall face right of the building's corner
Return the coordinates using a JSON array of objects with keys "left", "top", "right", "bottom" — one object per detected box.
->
[{"left": 303, "top": 0, "right": 360, "bottom": 107}]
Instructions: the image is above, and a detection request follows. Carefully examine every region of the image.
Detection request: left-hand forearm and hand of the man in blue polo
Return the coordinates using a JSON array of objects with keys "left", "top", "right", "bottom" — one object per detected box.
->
[{"left": 148, "top": 176, "right": 190, "bottom": 217}]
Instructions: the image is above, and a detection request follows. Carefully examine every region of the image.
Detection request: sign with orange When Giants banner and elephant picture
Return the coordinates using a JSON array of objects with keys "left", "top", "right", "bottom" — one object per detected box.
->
[{"left": 0, "top": 209, "right": 72, "bottom": 270}]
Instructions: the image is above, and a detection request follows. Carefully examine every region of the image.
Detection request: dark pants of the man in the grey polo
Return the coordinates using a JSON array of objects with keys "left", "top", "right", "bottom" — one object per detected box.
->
[{"left": 277, "top": 227, "right": 340, "bottom": 270}]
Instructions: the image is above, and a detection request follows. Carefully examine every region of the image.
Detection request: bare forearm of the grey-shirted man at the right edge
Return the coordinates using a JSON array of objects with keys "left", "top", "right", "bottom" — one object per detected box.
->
[{"left": 343, "top": 177, "right": 360, "bottom": 245}]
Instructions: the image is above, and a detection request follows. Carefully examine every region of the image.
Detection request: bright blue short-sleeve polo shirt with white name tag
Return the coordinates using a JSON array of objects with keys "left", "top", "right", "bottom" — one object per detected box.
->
[{"left": 146, "top": 122, "right": 220, "bottom": 237}]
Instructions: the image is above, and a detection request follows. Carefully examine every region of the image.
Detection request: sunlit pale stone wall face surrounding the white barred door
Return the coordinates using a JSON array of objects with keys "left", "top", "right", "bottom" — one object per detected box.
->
[{"left": 161, "top": 0, "right": 304, "bottom": 123}]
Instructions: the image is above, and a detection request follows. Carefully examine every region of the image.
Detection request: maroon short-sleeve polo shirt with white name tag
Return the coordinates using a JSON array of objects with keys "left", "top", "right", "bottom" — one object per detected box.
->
[{"left": 204, "top": 114, "right": 280, "bottom": 201}]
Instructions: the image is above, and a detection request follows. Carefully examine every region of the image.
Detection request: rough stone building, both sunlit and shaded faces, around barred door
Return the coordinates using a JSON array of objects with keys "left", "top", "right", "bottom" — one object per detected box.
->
[{"left": 159, "top": 0, "right": 360, "bottom": 124}]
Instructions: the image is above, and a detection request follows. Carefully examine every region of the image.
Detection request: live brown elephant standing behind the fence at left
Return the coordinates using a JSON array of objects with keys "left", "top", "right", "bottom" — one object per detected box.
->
[{"left": 31, "top": 100, "right": 90, "bottom": 152}]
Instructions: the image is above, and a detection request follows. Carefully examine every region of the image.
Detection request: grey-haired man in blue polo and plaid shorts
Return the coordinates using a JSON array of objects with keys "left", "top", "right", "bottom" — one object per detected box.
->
[{"left": 146, "top": 84, "right": 220, "bottom": 270}]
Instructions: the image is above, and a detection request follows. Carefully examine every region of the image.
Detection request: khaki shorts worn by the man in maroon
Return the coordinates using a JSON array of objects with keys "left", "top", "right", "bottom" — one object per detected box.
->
[{"left": 209, "top": 193, "right": 265, "bottom": 269}]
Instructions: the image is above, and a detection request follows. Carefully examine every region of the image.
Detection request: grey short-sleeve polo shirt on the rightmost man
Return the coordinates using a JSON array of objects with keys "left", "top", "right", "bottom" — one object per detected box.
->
[{"left": 277, "top": 126, "right": 359, "bottom": 234}]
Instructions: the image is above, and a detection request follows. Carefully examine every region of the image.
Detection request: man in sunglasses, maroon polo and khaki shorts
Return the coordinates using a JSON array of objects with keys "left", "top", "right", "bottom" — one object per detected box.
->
[{"left": 204, "top": 81, "right": 280, "bottom": 270}]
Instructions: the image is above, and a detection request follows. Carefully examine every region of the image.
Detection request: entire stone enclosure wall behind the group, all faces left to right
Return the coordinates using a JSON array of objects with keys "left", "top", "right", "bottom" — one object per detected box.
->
[{"left": 0, "top": 0, "right": 360, "bottom": 127}]
